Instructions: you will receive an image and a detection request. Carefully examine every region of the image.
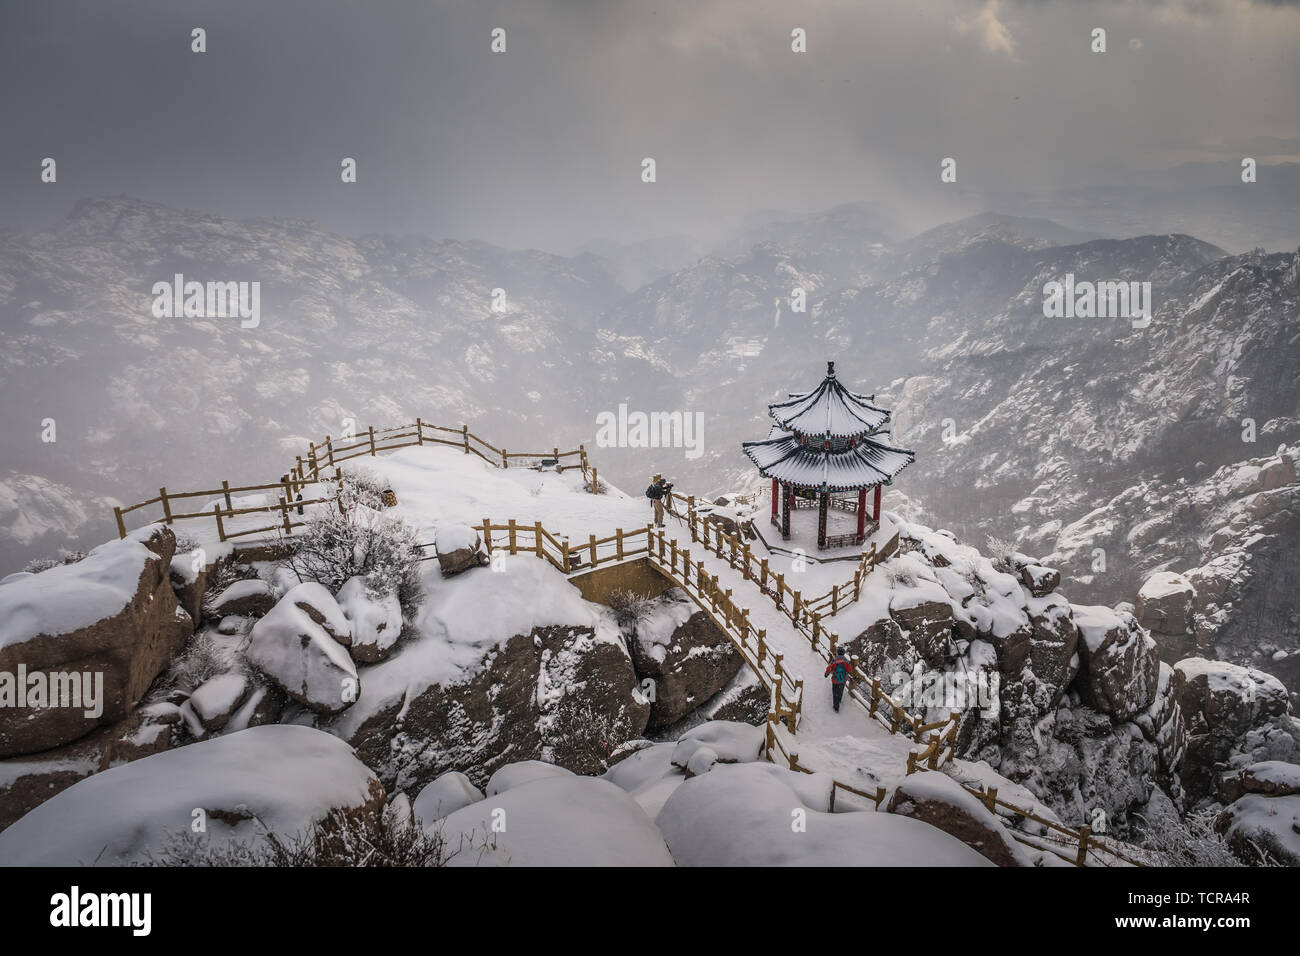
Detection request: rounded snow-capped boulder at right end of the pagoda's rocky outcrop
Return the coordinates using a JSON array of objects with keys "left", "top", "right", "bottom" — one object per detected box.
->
[{"left": 1073, "top": 605, "right": 1160, "bottom": 719}]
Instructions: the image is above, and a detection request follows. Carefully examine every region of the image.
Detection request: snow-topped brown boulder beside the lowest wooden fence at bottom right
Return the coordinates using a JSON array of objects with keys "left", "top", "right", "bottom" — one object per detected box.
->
[{"left": 887, "top": 773, "right": 1035, "bottom": 866}]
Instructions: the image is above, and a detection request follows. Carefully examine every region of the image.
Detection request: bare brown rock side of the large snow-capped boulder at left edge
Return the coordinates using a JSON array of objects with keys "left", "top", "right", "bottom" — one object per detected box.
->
[{"left": 0, "top": 527, "right": 194, "bottom": 757}]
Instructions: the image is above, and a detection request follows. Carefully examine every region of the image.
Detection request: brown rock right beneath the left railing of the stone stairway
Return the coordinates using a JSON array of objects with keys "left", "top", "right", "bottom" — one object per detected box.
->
[{"left": 629, "top": 611, "right": 745, "bottom": 731}]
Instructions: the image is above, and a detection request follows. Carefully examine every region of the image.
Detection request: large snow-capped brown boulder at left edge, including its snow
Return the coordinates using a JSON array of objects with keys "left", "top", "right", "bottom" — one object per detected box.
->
[{"left": 0, "top": 525, "right": 194, "bottom": 757}]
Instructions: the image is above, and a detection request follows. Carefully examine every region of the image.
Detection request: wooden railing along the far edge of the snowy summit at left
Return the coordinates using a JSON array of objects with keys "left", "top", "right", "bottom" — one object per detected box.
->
[{"left": 113, "top": 419, "right": 599, "bottom": 541}]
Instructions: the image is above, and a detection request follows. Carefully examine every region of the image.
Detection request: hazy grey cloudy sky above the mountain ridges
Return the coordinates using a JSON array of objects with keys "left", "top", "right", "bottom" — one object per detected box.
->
[{"left": 0, "top": 0, "right": 1300, "bottom": 251}]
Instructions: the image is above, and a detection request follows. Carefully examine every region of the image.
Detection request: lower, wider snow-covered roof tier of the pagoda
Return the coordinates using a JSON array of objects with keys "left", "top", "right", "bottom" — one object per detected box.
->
[{"left": 741, "top": 433, "right": 917, "bottom": 490}]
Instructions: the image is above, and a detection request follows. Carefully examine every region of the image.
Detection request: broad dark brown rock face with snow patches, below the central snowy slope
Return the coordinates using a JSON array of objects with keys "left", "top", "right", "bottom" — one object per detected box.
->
[{"left": 347, "top": 626, "right": 650, "bottom": 790}]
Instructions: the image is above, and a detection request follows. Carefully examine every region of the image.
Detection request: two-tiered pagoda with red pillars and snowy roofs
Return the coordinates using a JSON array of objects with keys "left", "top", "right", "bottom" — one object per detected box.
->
[{"left": 741, "top": 362, "right": 917, "bottom": 549}]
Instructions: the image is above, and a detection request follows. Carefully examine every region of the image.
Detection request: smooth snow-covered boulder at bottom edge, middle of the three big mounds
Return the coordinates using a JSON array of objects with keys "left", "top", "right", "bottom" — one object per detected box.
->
[{"left": 441, "top": 774, "right": 672, "bottom": 866}]
